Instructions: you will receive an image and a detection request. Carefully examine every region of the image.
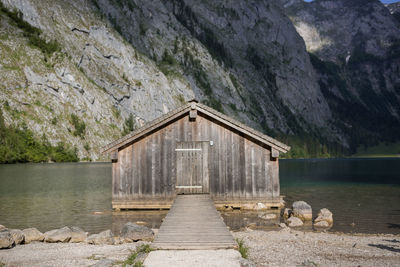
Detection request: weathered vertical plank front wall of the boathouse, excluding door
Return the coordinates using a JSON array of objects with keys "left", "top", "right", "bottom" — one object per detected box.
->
[{"left": 113, "top": 113, "right": 280, "bottom": 201}]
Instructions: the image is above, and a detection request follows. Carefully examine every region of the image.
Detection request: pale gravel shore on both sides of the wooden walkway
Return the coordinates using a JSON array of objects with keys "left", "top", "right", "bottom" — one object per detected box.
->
[{"left": 0, "top": 228, "right": 400, "bottom": 267}]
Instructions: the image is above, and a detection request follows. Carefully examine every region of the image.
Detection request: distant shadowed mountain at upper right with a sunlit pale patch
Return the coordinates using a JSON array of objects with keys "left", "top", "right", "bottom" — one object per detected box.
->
[{"left": 282, "top": 0, "right": 400, "bottom": 152}]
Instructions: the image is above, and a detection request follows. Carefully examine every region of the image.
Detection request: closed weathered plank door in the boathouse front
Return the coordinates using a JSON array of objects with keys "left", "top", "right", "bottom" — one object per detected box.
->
[{"left": 175, "top": 142, "right": 209, "bottom": 194}]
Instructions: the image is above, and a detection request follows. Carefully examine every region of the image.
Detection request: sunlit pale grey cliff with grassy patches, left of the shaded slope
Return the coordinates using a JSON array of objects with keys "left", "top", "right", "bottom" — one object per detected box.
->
[{"left": 0, "top": 0, "right": 194, "bottom": 160}]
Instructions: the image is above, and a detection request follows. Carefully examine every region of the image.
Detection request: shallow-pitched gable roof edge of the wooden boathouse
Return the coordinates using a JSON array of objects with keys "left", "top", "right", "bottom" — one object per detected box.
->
[{"left": 103, "top": 100, "right": 290, "bottom": 153}]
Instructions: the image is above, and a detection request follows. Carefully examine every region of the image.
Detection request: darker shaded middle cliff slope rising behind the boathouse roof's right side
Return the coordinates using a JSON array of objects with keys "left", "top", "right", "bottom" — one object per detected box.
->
[{"left": 97, "top": 0, "right": 331, "bottom": 133}]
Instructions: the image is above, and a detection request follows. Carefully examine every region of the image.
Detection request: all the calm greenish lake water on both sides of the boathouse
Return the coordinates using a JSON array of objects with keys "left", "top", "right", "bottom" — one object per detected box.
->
[{"left": 0, "top": 159, "right": 400, "bottom": 234}]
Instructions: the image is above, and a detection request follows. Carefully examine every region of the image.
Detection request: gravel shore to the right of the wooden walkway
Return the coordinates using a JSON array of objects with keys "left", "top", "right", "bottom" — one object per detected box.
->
[{"left": 233, "top": 228, "right": 400, "bottom": 267}]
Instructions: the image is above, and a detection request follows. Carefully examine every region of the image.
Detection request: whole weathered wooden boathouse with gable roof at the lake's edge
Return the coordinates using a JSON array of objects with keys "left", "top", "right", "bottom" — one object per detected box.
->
[{"left": 104, "top": 100, "right": 290, "bottom": 209}]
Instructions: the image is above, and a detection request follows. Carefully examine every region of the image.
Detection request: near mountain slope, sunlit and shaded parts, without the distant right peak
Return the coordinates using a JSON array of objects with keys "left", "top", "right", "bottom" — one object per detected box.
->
[{"left": 0, "top": 0, "right": 341, "bottom": 159}]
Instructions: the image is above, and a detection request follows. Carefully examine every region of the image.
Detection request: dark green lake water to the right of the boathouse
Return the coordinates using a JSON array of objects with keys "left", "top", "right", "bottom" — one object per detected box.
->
[{"left": 280, "top": 158, "right": 400, "bottom": 234}]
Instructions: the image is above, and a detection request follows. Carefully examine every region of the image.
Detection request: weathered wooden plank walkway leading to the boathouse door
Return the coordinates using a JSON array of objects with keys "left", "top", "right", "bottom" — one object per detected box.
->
[{"left": 153, "top": 194, "right": 237, "bottom": 249}]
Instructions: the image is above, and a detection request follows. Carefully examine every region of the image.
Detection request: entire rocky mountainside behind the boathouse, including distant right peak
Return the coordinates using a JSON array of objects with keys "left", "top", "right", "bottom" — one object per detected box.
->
[{"left": 0, "top": 0, "right": 399, "bottom": 160}]
